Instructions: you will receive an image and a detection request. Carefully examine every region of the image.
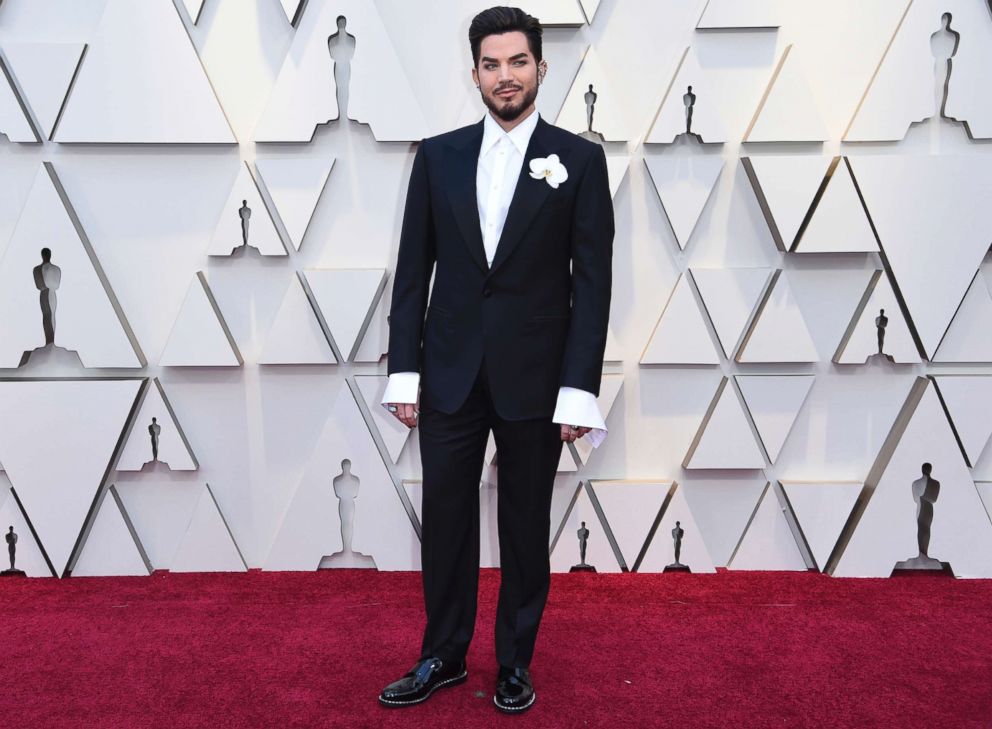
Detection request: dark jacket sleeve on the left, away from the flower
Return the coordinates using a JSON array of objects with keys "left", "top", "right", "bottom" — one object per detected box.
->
[{"left": 387, "top": 142, "right": 436, "bottom": 374}]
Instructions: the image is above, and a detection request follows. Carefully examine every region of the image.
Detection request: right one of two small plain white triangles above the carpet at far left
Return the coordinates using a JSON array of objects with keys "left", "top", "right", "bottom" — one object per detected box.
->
[{"left": 169, "top": 484, "right": 248, "bottom": 572}]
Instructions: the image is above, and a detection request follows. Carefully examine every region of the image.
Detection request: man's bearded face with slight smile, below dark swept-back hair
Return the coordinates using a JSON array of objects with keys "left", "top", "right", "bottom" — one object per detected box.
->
[{"left": 472, "top": 31, "right": 544, "bottom": 122}]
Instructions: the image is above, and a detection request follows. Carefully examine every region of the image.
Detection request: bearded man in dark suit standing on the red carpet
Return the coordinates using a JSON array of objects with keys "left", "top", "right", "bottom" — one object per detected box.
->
[{"left": 379, "top": 7, "right": 614, "bottom": 712}]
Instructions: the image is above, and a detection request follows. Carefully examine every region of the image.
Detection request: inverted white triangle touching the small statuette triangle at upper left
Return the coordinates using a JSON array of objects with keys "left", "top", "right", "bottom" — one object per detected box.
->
[{"left": 255, "top": 156, "right": 334, "bottom": 250}]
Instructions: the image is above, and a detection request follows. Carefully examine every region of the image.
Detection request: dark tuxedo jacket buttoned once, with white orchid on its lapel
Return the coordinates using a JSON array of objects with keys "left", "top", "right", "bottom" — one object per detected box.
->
[{"left": 388, "top": 111, "right": 614, "bottom": 420}]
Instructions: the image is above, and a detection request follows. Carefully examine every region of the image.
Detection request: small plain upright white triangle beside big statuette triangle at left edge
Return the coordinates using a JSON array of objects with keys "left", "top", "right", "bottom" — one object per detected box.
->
[{"left": 159, "top": 271, "right": 243, "bottom": 367}]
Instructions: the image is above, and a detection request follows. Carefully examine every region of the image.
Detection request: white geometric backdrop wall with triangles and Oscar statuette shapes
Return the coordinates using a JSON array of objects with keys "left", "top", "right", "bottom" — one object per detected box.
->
[{"left": 0, "top": 0, "right": 992, "bottom": 577}]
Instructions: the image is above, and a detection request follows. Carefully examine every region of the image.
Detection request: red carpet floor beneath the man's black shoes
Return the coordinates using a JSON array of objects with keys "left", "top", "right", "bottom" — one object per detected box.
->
[{"left": 0, "top": 570, "right": 992, "bottom": 729}]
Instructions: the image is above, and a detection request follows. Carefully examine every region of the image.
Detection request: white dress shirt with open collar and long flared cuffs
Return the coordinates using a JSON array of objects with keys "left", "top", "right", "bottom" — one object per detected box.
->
[{"left": 382, "top": 110, "right": 607, "bottom": 447}]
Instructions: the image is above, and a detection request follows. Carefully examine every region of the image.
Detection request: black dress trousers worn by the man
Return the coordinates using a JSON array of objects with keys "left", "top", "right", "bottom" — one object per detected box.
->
[{"left": 418, "top": 360, "right": 563, "bottom": 668}]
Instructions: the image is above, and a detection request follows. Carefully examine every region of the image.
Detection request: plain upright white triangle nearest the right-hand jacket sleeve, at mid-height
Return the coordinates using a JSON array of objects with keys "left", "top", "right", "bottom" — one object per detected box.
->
[{"left": 641, "top": 274, "right": 720, "bottom": 364}]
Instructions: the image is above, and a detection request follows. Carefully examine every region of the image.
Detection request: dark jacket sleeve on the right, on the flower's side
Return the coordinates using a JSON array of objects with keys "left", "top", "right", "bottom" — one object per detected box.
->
[{"left": 559, "top": 144, "right": 614, "bottom": 396}]
